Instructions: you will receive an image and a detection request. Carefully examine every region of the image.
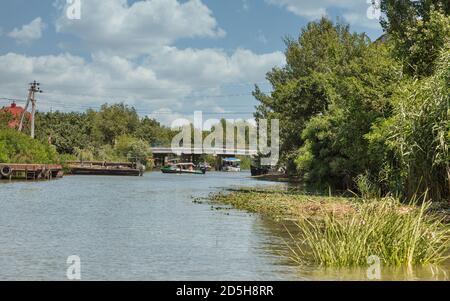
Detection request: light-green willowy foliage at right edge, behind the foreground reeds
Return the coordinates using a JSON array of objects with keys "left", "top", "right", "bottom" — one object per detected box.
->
[{"left": 366, "top": 43, "right": 450, "bottom": 200}]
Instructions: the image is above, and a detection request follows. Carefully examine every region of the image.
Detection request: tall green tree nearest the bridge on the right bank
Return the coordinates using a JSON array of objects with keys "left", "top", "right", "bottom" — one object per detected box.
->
[{"left": 253, "top": 19, "right": 371, "bottom": 172}]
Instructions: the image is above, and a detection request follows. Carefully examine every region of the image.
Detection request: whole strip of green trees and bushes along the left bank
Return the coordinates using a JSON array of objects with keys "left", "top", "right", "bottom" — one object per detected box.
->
[{"left": 0, "top": 104, "right": 174, "bottom": 165}]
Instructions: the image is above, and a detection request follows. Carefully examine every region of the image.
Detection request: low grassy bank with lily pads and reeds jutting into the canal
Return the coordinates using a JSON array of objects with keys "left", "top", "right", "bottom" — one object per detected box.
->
[{"left": 213, "top": 190, "right": 450, "bottom": 267}]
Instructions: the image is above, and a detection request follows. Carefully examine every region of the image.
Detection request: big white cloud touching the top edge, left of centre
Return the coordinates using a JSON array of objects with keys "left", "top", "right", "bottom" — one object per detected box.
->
[{"left": 56, "top": 0, "right": 225, "bottom": 56}]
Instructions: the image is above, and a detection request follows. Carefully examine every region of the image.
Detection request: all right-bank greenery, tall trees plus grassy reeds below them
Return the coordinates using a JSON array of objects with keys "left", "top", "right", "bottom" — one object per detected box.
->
[{"left": 221, "top": 0, "right": 450, "bottom": 267}]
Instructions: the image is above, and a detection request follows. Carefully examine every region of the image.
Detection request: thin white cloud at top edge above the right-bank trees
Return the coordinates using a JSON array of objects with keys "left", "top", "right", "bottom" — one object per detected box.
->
[{"left": 265, "top": 0, "right": 380, "bottom": 29}]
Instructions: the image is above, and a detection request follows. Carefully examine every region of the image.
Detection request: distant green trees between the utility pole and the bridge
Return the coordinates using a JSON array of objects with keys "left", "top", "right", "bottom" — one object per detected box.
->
[{"left": 36, "top": 104, "right": 173, "bottom": 160}]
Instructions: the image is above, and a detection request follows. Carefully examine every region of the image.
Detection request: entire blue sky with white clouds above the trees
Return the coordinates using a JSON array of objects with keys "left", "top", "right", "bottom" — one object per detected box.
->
[{"left": 0, "top": 0, "right": 382, "bottom": 125}]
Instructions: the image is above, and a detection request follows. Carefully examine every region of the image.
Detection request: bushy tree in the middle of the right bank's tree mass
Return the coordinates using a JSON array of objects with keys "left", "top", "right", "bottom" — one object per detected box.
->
[{"left": 296, "top": 43, "right": 401, "bottom": 189}]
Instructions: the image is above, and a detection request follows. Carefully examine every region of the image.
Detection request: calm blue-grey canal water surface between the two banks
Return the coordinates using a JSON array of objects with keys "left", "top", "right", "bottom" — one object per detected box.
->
[{"left": 0, "top": 172, "right": 448, "bottom": 280}]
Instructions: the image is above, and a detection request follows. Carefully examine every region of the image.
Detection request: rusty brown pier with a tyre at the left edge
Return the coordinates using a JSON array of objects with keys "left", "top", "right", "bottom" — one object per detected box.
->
[{"left": 0, "top": 163, "right": 63, "bottom": 181}]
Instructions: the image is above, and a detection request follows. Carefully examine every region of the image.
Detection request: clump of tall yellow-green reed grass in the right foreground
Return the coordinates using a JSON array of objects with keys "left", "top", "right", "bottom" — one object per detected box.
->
[{"left": 288, "top": 198, "right": 450, "bottom": 267}]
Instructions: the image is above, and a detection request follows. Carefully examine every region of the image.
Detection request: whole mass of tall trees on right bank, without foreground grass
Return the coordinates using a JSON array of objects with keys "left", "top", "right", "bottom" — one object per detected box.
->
[{"left": 254, "top": 0, "right": 450, "bottom": 201}]
